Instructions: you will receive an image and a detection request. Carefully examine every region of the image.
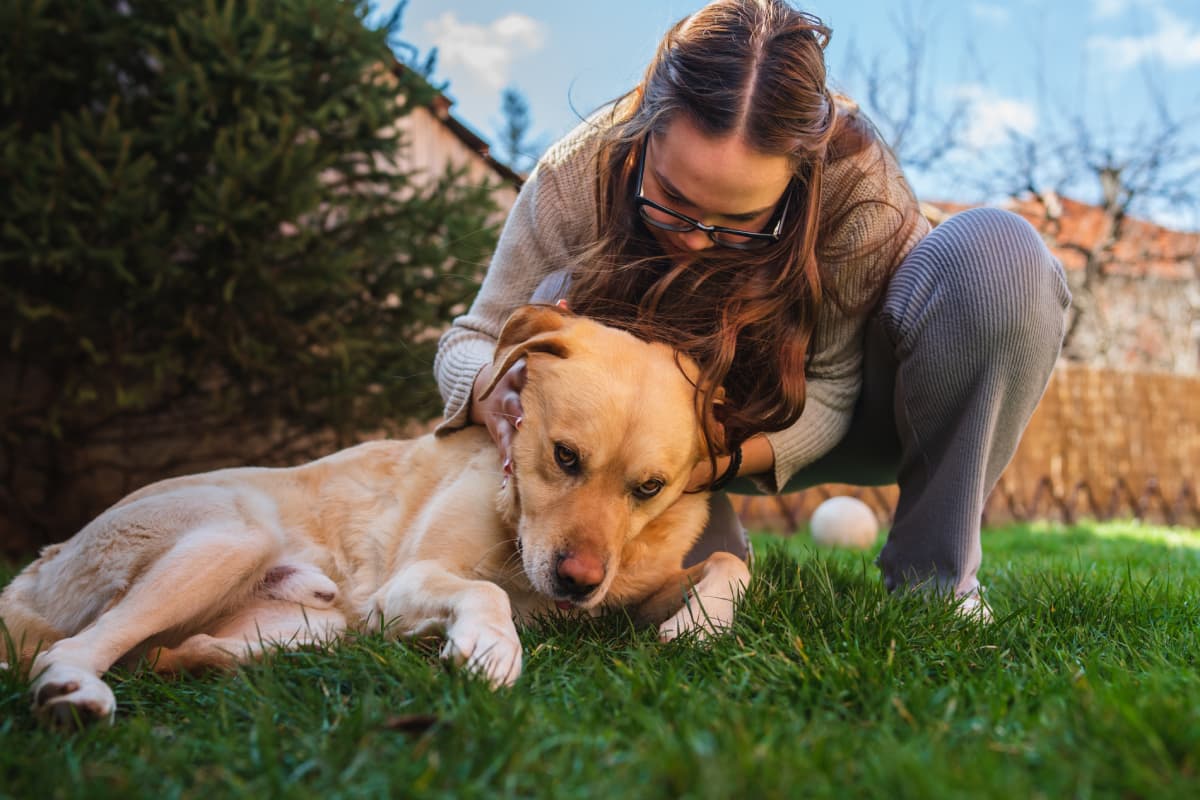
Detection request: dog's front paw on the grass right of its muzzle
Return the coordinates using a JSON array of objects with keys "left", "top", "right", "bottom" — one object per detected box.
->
[{"left": 637, "top": 553, "right": 750, "bottom": 642}]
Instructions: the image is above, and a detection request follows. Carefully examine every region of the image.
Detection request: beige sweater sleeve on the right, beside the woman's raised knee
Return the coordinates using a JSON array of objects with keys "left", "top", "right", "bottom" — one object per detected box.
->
[{"left": 755, "top": 136, "right": 929, "bottom": 493}]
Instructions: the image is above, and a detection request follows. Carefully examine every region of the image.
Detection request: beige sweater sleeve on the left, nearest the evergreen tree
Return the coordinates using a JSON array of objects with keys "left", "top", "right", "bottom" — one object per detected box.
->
[{"left": 433, "top": 128, "right": 594, "bottom": 429}]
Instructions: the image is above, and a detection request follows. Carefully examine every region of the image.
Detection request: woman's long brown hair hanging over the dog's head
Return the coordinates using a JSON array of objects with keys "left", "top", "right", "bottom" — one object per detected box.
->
[{"left": 569, "top": 0, "right": 902, "bottom": 465}]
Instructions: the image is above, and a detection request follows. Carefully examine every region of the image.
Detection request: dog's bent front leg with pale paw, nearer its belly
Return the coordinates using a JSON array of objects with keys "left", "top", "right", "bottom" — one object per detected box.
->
[{"left": 371, "top": 561, "right": 521, "bottom": 687}]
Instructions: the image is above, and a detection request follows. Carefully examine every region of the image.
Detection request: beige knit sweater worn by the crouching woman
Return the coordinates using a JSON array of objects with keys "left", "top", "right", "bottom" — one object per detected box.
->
[{"left": 433, "top": 109, "right": 929, "bottom": 492}]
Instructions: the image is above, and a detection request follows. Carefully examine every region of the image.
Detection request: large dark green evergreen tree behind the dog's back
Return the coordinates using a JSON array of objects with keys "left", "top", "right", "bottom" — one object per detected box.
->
[{"left": 0, "top": 0, "right": 506, "bottom": 552}]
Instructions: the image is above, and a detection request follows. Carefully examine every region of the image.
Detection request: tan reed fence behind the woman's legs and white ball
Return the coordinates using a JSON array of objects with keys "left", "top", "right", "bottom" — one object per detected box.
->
[{"left": 733, "top": 365, "right": 1200, "bottom": 533}]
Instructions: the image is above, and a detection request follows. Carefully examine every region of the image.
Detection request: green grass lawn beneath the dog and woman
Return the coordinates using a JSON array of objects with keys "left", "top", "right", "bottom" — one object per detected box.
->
[{"left": 0, "top": 524, "right": 1200, "bottom": 800}]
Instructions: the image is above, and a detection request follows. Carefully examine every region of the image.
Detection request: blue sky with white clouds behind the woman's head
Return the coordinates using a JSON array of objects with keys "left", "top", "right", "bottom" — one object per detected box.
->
[{"left": 369, "top": 0, "right": 1200, "bottom": 228}]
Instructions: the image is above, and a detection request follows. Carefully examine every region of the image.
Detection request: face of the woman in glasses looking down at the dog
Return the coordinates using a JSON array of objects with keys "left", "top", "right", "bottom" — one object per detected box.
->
[{"left": 642, "top": 116, "right": 792, "bottom": 251}]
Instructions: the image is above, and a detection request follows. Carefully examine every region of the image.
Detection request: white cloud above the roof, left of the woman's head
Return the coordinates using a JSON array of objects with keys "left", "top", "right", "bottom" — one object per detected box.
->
[{"left": 425, "top": 11, "right": 546, "bottom": 90}]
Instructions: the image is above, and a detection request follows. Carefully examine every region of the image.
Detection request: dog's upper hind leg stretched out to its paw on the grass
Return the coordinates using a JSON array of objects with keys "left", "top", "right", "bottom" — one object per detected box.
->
[{"left": 31, "top": 521, "right": 280, "bottom": 727}]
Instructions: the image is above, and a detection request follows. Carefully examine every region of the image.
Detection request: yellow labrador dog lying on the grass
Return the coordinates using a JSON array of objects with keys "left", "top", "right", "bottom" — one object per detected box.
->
[{"left": 0, "top": 306, "right": 749, "bottom": 724}]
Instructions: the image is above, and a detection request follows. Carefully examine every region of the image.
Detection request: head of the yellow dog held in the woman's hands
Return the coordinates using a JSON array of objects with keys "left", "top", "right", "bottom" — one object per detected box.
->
[{"left": 485, "top": 306, "right": 707, "bottom": 608}]
